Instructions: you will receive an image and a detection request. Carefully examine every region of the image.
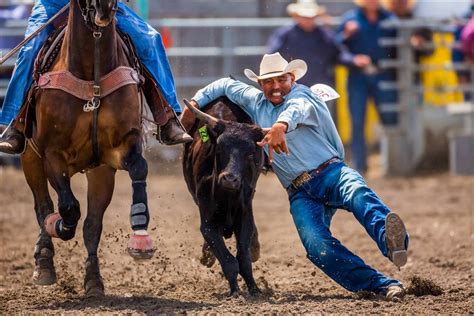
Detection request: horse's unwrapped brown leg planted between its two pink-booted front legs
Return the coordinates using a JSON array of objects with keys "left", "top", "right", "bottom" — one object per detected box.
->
[{"left": 83, "top": 166, "right": 115, "bottom": 297}]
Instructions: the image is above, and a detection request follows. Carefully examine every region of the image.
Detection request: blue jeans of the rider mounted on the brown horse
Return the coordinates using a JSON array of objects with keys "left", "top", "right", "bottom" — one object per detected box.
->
[{"left": 0, "top": 0, "right": 181, "bottom": 125}]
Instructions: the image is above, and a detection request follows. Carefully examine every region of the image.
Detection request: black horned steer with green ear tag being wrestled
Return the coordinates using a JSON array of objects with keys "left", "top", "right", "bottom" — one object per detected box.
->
[{"left": 183, "top": 97, "right": 265, "bottom": 296}]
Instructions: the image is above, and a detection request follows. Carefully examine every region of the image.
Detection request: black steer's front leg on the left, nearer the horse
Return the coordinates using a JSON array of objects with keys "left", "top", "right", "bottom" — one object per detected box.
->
[{"left": 200, "top": 216, "right": 239, "bottom": 296}]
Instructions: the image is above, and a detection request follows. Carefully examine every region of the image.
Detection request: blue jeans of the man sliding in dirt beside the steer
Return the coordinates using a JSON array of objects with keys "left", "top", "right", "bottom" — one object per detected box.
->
[{"left": 289, "top": 162, "right": 408, "bottom": 293}]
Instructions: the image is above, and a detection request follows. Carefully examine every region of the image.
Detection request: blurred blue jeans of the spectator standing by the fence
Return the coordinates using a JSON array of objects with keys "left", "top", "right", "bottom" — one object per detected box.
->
[{"left": 347, "top": 72, "right": 398, "bottom": 172}]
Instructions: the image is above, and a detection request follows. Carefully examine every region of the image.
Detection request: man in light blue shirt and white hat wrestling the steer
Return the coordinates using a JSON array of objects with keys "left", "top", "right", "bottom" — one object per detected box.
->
[{"left": 182, "top": 53, "right": 408, "bottom": 300}]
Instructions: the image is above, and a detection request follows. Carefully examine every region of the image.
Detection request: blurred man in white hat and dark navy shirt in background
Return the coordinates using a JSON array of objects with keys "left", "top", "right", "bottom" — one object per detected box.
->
[{"left": 268, "top": 0, "right": 370, "bottom": 87}]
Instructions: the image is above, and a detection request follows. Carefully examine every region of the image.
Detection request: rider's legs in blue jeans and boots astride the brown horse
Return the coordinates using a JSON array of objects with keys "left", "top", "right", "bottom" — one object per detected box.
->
[{"left": 0, "top": 0, "right": 192, "bottom": 154}]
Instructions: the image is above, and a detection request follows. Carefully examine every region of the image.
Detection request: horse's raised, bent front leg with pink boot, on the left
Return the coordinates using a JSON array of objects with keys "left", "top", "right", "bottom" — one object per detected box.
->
[{"left": 44, "top": 152, "right": 81, "bottom": 240}]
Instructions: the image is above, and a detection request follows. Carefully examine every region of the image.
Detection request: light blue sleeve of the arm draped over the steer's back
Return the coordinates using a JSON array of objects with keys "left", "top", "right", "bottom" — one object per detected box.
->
[{"left": 192, "top": 78, "right": 262, "bottom": 118}]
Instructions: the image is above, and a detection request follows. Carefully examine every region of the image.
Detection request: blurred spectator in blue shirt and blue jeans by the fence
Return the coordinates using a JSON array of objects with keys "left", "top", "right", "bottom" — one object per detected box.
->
[{"left": 337, "top": 0, "right": 397, "bottom": 172}]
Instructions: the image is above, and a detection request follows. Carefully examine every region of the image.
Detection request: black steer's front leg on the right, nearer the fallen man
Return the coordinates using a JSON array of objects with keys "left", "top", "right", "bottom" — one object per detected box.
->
[{"left": 235, "top": 206, "right": 260, "bottom": 295}]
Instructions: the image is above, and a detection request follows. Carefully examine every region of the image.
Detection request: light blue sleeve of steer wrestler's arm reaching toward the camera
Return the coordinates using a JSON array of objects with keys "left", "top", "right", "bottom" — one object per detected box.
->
[{"left": 277, "top": 98, "right": 318, "bottom": 133}]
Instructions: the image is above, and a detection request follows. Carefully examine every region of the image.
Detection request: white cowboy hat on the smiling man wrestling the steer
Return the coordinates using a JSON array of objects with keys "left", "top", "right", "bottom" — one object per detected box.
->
[{"left": 244, "top": 53, "right": 308, "bottom": 82}]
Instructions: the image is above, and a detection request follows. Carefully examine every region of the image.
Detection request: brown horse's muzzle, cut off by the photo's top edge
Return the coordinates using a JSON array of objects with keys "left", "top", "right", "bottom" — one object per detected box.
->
[{"left": 79, "top": 0, "right": 118, "bottom": 27}]
